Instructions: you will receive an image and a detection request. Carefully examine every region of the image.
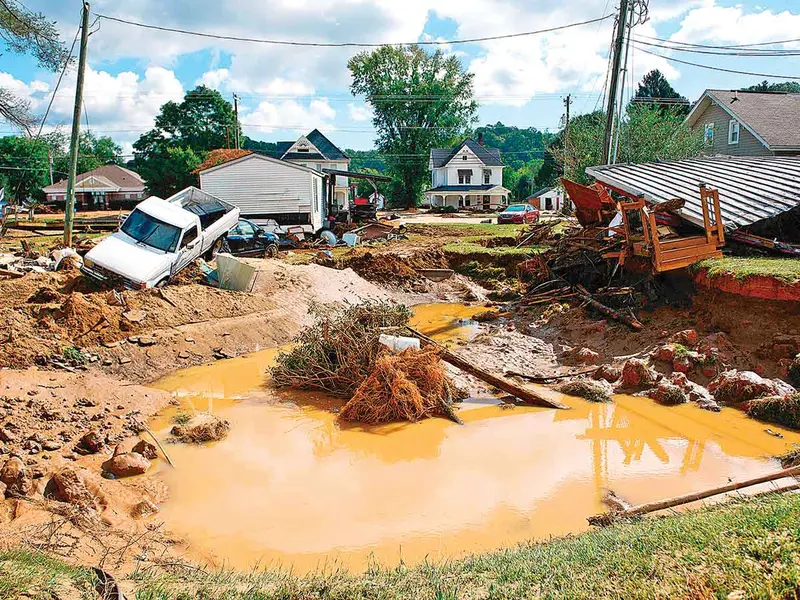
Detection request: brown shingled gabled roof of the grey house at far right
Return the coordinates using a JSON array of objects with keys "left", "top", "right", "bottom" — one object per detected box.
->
[{"left": 686, "top": 90, "right": 800, "bottom": 151}]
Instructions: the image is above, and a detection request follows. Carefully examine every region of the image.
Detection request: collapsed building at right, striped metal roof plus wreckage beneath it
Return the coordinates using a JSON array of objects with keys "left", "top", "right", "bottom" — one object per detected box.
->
[{"left": 584, "top": 156, "right": 800, "bottom": 254}]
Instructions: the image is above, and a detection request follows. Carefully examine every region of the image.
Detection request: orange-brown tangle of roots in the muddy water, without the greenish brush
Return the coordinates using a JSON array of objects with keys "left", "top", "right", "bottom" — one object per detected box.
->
[{"left": 339, "top": 347, "right": 465, "bottom": 424}]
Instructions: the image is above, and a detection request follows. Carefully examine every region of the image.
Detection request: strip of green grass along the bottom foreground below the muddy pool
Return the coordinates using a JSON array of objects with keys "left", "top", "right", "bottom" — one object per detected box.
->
[{"left": 0, "top": 494, "right": 800, "bottom": 600}]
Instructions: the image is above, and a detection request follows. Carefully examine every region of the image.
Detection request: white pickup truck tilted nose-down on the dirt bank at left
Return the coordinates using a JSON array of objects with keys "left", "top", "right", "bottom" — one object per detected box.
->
[{"left": 81, "top": 187, "right": 239, "bottom": 289}]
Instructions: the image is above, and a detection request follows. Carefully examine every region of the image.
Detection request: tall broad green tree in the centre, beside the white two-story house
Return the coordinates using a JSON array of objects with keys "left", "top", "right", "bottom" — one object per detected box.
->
[{"left": 347, "top": 46, "right": 478, "bottom": 206}]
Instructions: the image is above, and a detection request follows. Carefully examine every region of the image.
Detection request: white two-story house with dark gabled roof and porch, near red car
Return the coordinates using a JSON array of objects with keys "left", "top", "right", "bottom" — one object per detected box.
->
[{"left": 425, "top": 139, "right": 511, "bottom": 210}]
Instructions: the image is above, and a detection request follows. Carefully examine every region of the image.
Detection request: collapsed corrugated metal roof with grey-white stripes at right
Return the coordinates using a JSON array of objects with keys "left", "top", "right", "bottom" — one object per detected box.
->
[{"left": 586, "top": 156, "right": 800, "bottom": 230}]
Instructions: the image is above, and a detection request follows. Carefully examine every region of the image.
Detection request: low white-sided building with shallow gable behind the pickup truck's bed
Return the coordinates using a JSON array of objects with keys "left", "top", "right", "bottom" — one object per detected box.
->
[{"left": 199, "top": 154, "right": 327, "bottom": 232}]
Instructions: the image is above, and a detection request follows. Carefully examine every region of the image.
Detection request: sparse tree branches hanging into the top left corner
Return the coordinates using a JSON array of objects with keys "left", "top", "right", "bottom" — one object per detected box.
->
[{"left": 0, "top": 0, "right": 69, "bottom": 134}]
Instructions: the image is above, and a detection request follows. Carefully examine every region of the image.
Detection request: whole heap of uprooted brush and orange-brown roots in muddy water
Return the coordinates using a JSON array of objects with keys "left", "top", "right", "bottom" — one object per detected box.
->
[{"left": 271, "top": 301, "right": 464, "bottom": 424}]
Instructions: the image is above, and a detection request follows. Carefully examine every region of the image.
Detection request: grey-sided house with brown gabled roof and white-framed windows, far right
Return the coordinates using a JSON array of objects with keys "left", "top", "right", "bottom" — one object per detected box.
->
[{"left": 686, "top": 90, "right": 800, "bottom": 156}]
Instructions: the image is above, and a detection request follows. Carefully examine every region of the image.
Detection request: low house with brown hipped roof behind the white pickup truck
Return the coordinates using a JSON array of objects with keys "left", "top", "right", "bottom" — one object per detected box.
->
[{"left": 42, "top": 165, "right": 145, "bottom": 210}]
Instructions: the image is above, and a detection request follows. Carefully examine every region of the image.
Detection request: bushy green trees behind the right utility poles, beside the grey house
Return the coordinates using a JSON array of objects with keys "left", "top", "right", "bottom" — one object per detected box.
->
[{"left": 556, "top": 104, "right": 703, "bottom": 185}]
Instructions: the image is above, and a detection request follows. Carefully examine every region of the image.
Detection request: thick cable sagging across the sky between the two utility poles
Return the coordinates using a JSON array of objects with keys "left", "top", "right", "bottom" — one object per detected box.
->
[{"left": 97, "top": 14, "right": 614, "bottom": 48}]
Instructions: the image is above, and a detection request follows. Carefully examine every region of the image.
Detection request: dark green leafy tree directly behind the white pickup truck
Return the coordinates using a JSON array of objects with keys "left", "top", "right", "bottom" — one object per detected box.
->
[{"left": 133, "top": 85, "right": 236, "bottom": 196}]
